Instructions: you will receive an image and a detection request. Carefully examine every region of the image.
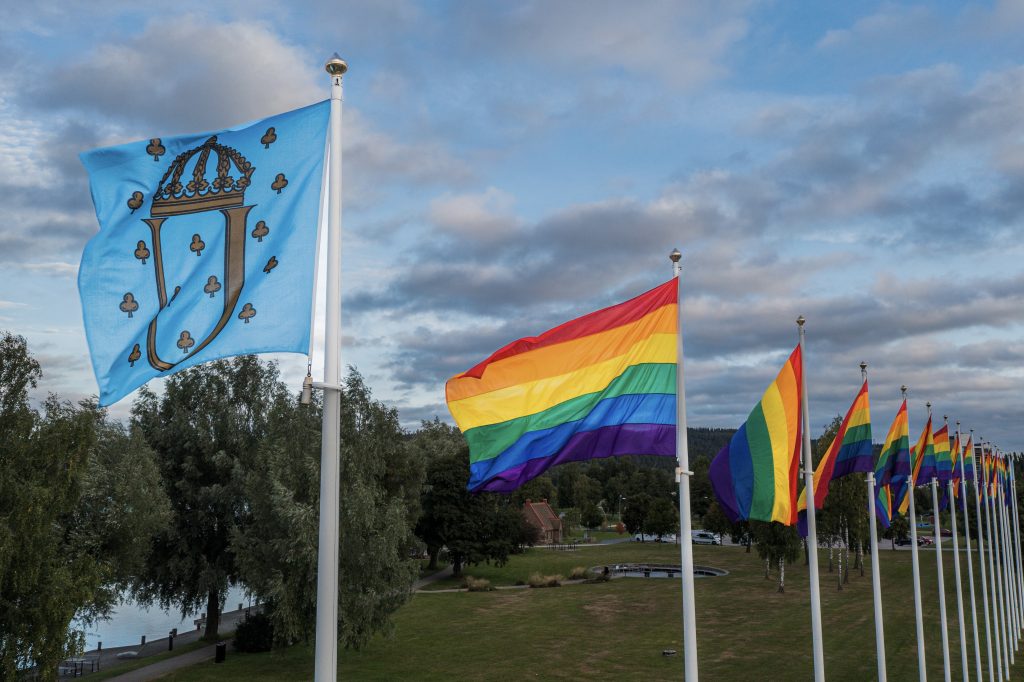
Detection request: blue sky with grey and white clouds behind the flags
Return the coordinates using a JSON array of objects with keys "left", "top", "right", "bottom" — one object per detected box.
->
[{"left": 0, "top": 0, "right": 1024, "bottom": 450}]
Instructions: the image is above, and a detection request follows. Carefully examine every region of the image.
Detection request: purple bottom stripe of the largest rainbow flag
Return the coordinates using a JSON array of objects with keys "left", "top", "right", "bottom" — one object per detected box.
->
[{"left": 472, "top": 424, "right": 676, "bottom": 493}]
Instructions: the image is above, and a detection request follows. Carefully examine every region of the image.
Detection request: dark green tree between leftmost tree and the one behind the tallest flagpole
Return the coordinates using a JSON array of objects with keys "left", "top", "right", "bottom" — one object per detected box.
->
[{"left": 132, "top": 355, "right": 285, "bottom": 639}]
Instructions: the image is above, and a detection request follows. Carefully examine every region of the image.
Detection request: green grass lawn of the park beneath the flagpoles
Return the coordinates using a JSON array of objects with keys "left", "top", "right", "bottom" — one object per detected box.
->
[{"left": 165, "top": 543, "right": 1011, "bottom": 682}]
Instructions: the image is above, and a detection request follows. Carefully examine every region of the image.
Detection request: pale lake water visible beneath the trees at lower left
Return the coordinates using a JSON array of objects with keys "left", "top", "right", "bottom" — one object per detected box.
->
[{"left": 75, "top": 587, "right": 249, "bottom": 651}]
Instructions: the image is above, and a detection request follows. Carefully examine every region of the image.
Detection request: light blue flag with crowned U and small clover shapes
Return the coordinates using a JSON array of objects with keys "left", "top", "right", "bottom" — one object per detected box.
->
[{"left": 78, "top": 101, "right": 330, "bottom": 406}]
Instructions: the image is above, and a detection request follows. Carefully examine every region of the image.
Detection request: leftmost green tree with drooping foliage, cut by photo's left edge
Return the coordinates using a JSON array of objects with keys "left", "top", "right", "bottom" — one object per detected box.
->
[{"left": 0, "top": 334, "right": 166, "bottom": 680}]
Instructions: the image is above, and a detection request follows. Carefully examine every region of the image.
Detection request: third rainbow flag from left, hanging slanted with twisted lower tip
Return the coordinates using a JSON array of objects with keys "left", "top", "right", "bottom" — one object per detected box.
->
[{"left": 797, "top": 381, "right": 874, "bottom": 537}]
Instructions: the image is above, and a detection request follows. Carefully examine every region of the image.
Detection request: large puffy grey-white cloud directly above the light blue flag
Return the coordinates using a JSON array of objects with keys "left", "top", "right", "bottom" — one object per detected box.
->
[{"left": 30, "top": 15, "right": 327, "bottom": 135}]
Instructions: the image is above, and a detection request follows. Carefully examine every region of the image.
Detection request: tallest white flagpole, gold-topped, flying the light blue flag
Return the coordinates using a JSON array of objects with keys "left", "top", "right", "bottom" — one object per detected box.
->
[{"left": 313, "top": 54, "right": 348, "bottom": 682}]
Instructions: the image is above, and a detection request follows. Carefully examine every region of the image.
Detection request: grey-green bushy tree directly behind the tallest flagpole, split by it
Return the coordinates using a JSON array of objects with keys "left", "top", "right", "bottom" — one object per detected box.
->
[{"left": 231, "top": 371, "right": 423, "bottom": 648}]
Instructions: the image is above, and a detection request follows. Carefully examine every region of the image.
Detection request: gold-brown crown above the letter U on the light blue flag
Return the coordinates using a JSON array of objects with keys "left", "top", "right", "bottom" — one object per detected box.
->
[{"left": 152, "top": 135, "right": 256, "bottom": 217}]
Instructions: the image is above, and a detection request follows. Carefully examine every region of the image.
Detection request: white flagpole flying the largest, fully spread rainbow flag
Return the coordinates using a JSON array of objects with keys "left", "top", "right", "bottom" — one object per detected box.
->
[{"left": 669, "top": 249, "right": 697, "bottom": 682}]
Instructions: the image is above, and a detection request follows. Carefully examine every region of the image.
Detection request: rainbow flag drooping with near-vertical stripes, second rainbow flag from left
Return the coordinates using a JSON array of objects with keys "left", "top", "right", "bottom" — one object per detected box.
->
[{"left": 708, "top": 346, "right": 803, "bottom": 525}]
